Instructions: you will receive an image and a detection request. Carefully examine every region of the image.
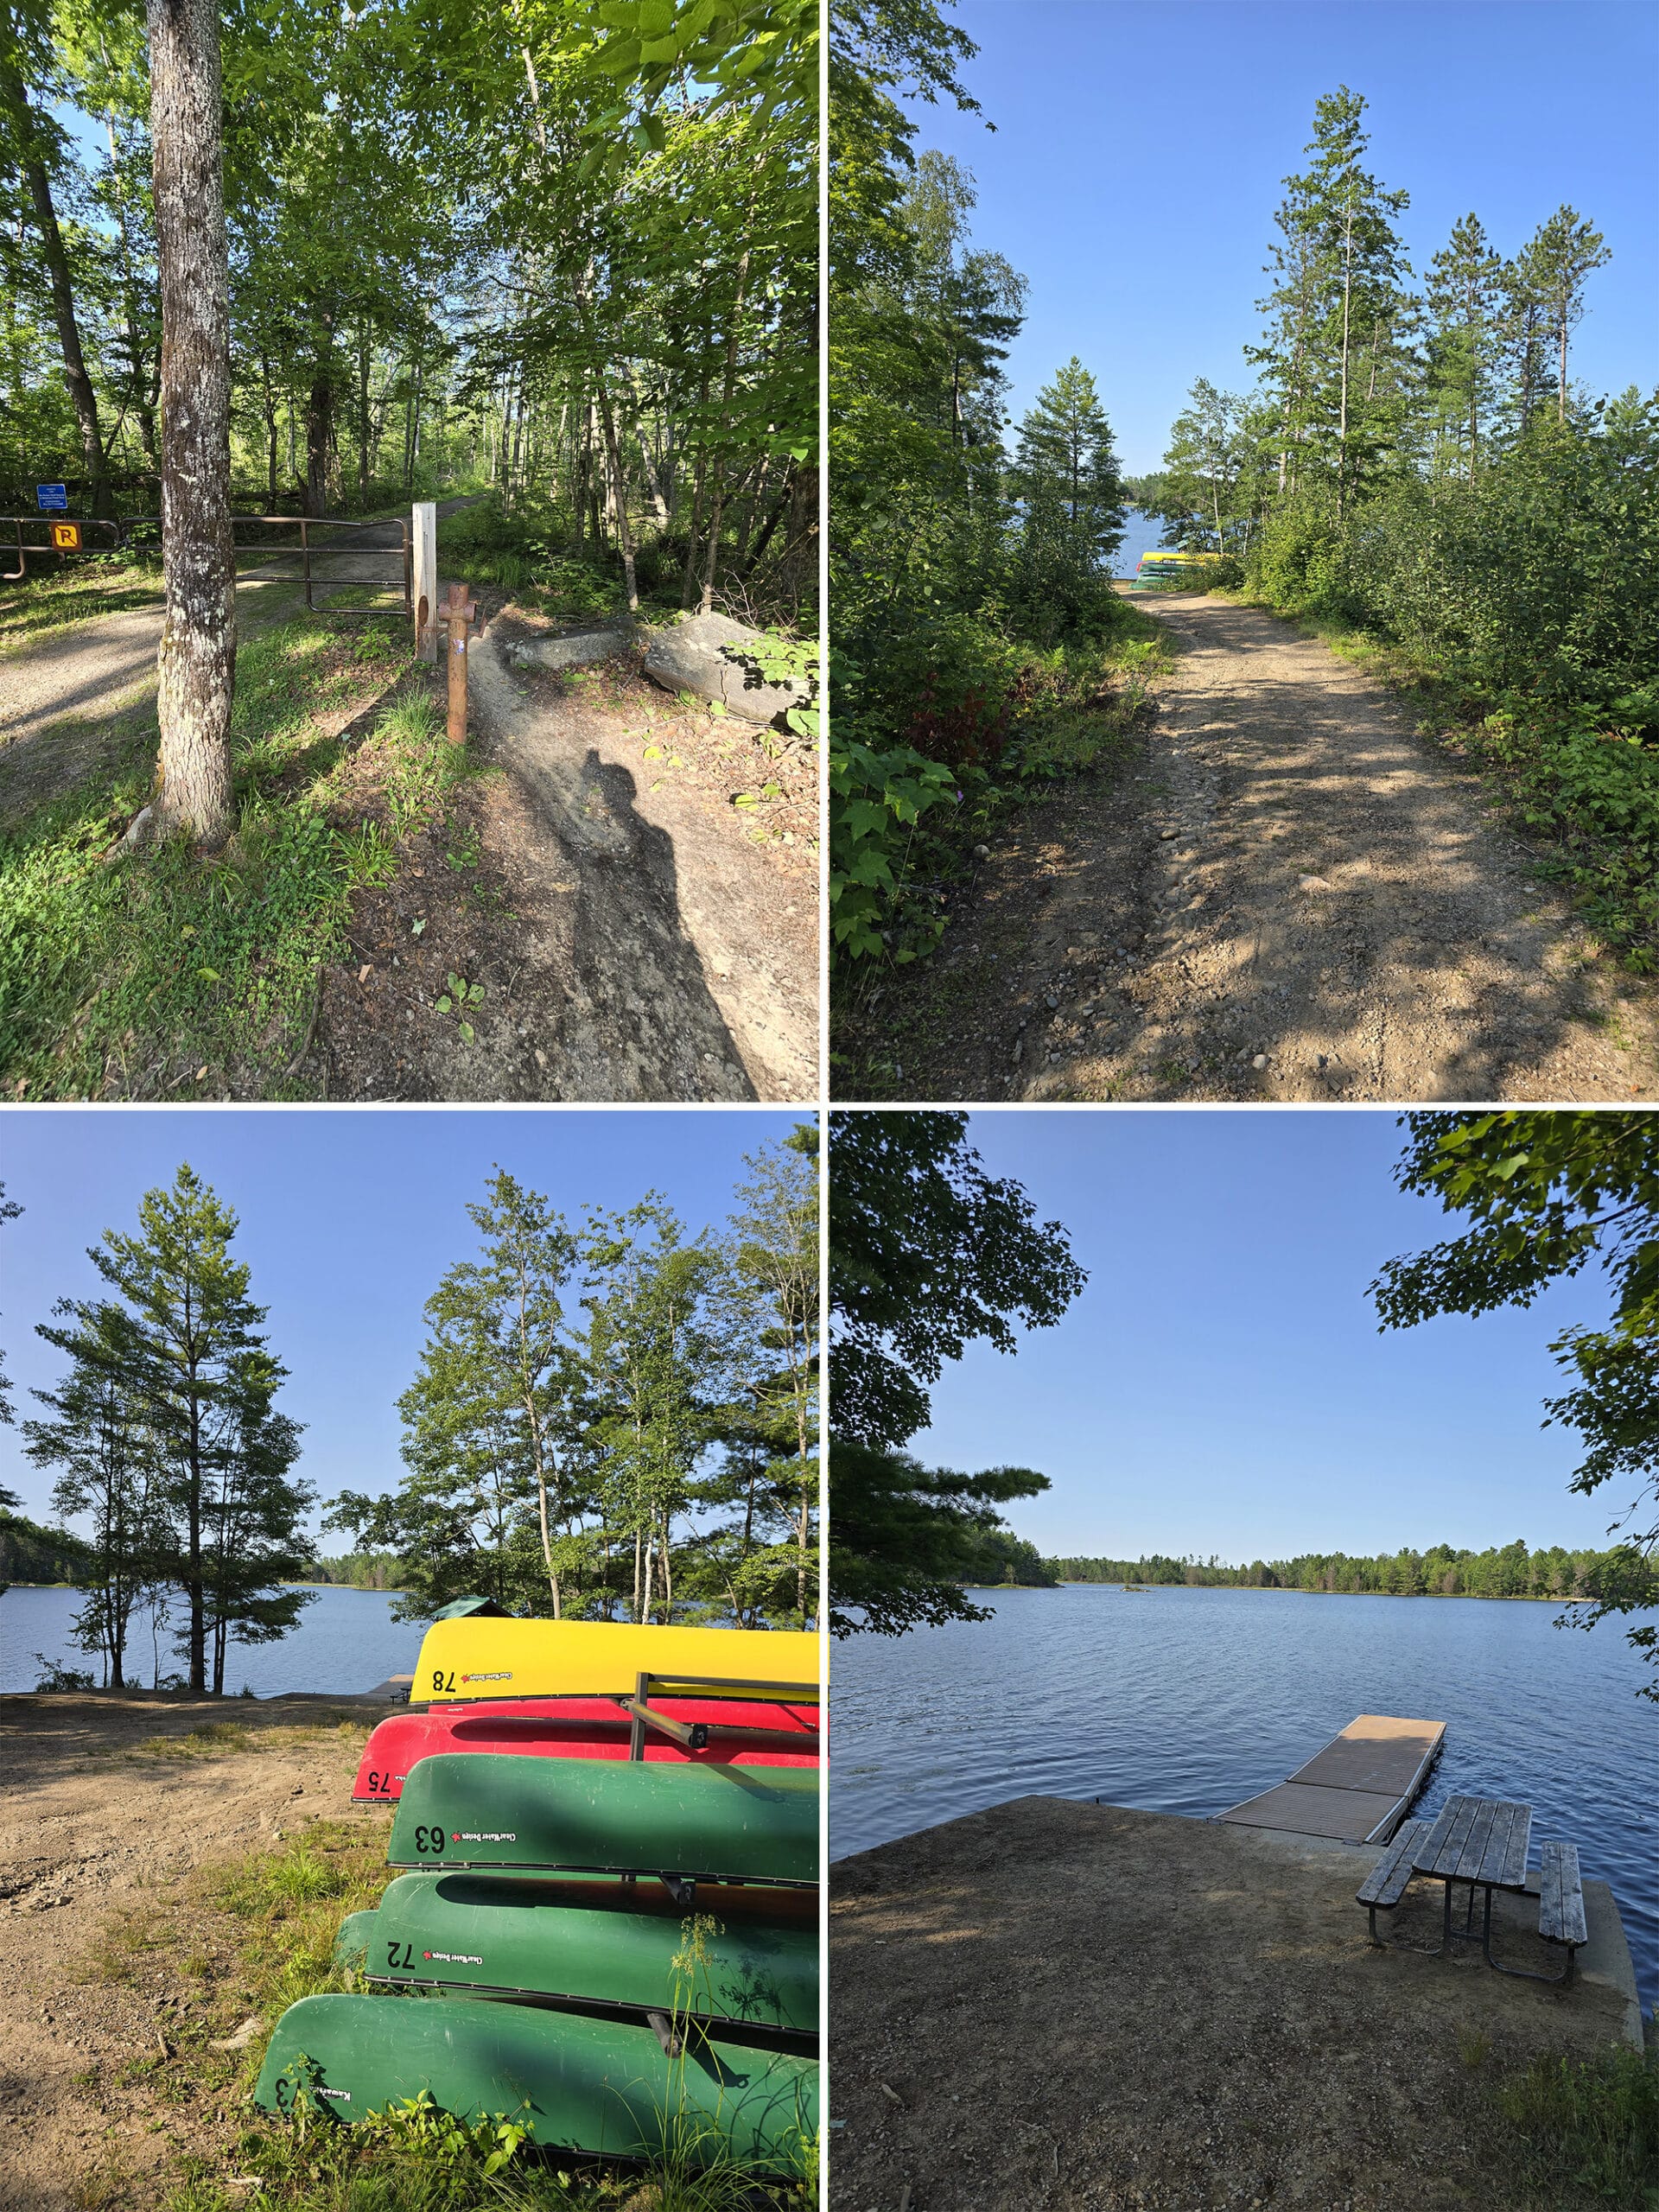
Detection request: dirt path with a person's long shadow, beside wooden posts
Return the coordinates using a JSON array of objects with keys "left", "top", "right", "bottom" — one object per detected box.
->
[{"left": 308, "top": 615, "right": 818, "bottom": 1102}]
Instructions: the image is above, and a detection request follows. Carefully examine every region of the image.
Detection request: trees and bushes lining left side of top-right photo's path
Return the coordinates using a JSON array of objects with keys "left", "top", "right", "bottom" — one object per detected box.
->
[{"left": 830, "top": 0, "right": 1141, "bottom": 973}]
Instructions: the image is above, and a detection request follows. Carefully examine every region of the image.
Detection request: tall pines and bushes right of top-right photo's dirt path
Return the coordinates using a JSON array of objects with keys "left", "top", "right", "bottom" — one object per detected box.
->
[{"left": 1135, "top": 86, "right": 1659, "bottom": 942}]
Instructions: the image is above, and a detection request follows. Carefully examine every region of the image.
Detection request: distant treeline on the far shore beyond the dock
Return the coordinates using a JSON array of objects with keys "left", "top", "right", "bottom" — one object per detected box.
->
[{"left": 1042, "top": 1540, "right": 1624, "bottom": 1599}]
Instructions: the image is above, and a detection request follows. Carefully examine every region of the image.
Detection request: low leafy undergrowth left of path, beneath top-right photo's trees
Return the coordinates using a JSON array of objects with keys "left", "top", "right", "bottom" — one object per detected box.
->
[{"left": 830, "top": 601, "right": 1173, "bottom": 977}]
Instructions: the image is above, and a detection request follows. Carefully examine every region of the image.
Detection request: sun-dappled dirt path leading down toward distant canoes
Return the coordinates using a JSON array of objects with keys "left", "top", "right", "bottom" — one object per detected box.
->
[{"left": 872, "top": 597, "right": 1659, "bottom": 1102}]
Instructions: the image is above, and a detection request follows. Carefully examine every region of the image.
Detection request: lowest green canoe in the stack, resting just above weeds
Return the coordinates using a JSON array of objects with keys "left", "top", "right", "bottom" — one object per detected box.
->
[{"left": 254, "top": 1998, "right": 818, "bottom": 2172}]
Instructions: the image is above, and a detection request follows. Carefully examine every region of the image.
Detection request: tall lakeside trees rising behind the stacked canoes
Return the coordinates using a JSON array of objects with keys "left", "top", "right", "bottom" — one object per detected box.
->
[{"left": 0, "top": 1126, "right": 818, "bottom": 1694}]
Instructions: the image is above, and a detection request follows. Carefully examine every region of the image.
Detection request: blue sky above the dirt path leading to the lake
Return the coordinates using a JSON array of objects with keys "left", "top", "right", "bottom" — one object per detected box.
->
[{"left": 912, "top": 0, "right": 1659, "bottom": 471}]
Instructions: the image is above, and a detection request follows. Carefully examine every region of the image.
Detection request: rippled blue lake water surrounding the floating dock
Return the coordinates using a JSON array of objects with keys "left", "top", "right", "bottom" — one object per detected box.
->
[{"left": 830, "top": 1584, "right": 1659, "bottom": 2008}]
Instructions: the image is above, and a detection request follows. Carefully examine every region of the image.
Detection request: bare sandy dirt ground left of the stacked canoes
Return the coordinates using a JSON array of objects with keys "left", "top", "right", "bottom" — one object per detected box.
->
[{"left": 0, "top": 1697, "right": 390, "bottom": 2212}]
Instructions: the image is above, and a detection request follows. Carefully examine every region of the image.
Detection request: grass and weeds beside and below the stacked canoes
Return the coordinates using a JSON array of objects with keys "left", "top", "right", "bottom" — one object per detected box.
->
[{"left": 151, "top": 1821, "right": 817, "bottom": 2212}]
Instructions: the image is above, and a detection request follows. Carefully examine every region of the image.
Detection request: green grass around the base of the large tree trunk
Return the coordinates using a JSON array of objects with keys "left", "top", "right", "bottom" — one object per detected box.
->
[{"left": 0, "top": 617, "right": 480, "bottom": 1099}]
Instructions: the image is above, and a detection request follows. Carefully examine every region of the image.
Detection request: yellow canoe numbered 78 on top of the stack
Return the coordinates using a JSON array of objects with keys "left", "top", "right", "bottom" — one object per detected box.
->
[{"left": 410, "top": 1615, "right": 818, "bottom": 1706}]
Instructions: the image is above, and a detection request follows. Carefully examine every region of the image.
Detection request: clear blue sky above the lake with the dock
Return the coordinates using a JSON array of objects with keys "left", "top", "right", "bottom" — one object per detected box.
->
[{"left": 913, "top": 1109, "right": 1628, "bottom": 1560}]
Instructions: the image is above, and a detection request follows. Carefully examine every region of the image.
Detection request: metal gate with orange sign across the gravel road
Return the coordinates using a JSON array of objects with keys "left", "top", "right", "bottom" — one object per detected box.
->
[{"left": 0, "top": 515, "right": 414, "bottom": 620}]
